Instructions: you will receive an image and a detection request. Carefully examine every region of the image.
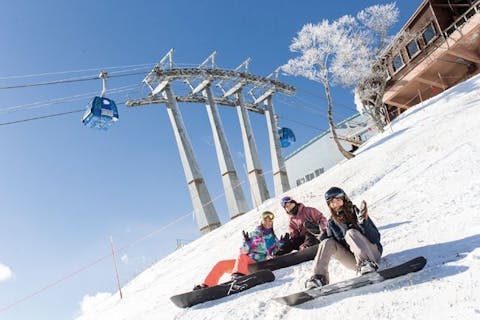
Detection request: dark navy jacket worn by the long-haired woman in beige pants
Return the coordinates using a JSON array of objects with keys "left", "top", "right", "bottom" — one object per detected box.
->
[{"left": 320, "top": 206, "right": 383, "bottom": 253}]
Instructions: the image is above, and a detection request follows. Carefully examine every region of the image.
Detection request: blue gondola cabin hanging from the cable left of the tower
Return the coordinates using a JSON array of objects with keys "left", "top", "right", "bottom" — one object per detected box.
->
[{"left": 82, "top": 72, "right": 118, "bottom": 130}]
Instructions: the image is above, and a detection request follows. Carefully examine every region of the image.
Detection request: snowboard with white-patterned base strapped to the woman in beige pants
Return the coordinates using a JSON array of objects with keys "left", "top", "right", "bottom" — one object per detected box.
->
[{"left": 273, "top": 257, "right": 427, "bottom": 306}]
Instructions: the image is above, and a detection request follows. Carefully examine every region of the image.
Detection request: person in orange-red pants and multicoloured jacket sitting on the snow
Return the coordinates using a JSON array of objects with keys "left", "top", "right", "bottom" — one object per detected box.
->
[{"left": 193, "top": 211, "right": 282, "bottom": 290}]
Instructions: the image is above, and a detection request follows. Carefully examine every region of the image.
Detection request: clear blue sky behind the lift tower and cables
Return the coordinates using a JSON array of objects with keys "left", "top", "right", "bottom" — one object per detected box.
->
[{"left": 0, "top": 0, "right": 420, "bottom": 319}]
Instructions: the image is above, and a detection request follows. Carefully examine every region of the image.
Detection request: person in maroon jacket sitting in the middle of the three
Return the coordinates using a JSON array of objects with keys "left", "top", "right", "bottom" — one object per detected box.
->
[{"left": 277, "top": 196, "right": 327, "bottom": 255}]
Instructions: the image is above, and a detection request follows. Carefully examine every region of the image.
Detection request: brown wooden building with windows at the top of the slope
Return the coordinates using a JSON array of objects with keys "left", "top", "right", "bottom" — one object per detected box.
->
[{"left": 383, "top": 0, "right": 480, "bottom": 118}]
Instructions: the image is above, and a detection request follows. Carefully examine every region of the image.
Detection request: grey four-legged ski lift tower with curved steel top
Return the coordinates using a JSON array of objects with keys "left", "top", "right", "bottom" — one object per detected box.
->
[{"left": 126, "top": 49, "right": 295, "bottom": 233}]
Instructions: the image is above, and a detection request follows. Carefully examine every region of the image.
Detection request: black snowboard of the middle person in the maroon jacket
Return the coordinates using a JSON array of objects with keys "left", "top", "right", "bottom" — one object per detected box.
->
[{"left": 248, "top": 244, "right": 318, "bottom": 272}]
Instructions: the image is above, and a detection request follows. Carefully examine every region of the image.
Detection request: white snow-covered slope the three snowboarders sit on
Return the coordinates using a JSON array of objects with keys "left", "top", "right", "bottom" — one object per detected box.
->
[{"left": 78, "top": 76, "right": 480, "bottom": 320}]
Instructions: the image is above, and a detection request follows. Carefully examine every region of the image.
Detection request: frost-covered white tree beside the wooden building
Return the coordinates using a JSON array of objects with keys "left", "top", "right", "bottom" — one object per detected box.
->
[{"left": 282, "top": 3, "right": 398, "bottom": 159}]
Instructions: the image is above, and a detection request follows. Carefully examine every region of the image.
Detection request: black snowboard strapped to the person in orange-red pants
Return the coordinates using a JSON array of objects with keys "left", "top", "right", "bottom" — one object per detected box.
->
[{"left": 170, "top": 270, "right": 275, "bottom": 308}]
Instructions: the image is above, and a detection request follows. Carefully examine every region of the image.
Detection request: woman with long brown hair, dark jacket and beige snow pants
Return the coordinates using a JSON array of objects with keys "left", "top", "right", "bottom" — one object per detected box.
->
[{"left": 305, "top": 187, "right": 383, "bottom": 288}]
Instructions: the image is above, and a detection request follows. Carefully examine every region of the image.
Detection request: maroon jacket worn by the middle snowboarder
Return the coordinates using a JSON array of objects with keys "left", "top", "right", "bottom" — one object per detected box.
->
[{"left": 288, "top": 203, "right": 327, "bottom": 250}]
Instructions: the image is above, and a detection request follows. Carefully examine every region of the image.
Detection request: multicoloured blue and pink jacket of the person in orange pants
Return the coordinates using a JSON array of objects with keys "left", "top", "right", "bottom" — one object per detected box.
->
[{"left": 240, "top": 225, "right": 281, "bottom": 261}]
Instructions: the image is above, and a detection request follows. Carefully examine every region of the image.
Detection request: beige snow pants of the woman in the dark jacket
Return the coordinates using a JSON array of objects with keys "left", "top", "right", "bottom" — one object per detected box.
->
[{"left": 313, "top": 229, "right": 382, "bottom": 281}]
